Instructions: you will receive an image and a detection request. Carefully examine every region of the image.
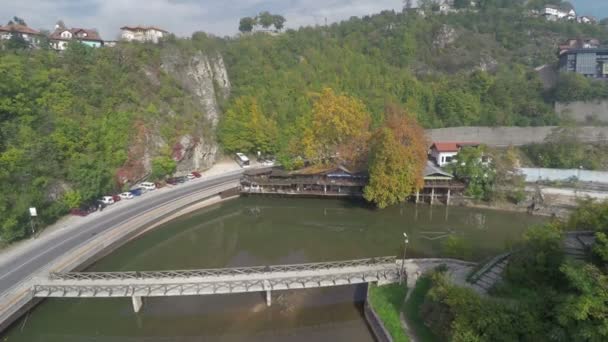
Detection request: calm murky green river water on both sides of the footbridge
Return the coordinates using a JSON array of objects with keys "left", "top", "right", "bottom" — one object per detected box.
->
[{"left": 0, "top": 197, "right": 543, "bottom": 342}]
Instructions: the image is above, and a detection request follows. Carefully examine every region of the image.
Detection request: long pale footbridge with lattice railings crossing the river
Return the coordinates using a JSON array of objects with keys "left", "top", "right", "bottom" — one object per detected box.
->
[{"left": 34, "top": 257, "right": 401, "bottom": 312}]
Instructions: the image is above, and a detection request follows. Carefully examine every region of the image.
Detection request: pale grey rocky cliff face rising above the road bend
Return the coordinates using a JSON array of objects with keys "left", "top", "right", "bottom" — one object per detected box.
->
[{"left": 117, "top": 47, "right": 231, "bottom": 183}]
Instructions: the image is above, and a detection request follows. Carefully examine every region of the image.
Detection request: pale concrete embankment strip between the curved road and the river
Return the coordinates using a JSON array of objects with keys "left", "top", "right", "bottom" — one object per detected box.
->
[{"left": 0, "top": 181, "right": 238, "bottom": 332}]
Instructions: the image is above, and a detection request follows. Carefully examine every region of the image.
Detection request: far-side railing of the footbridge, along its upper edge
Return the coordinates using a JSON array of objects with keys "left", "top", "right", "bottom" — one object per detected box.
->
[{"left": 49, "top": 256, "right": 396, "bottom": 281}]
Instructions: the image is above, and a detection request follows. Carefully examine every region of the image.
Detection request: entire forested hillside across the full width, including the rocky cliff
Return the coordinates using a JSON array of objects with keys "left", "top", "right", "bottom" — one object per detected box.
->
[{"left": 0, "top": 1, "right": 608, "bottom": 241}]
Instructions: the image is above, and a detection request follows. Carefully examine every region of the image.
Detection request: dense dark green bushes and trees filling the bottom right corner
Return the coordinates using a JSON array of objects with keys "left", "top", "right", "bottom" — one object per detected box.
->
[{"left": 421, "top": 201, "right": 608, "bottom": 341}]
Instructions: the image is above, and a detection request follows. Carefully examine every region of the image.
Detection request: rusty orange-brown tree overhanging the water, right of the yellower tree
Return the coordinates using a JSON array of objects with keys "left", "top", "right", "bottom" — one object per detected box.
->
[{"left": 364, "top": 107, "right": 427, "bottom": 208}]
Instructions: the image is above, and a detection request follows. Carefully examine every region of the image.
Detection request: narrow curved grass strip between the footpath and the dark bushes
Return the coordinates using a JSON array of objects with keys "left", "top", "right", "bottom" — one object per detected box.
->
[{"left": 404, "top": 277, "right": 439, "bottom": 342}]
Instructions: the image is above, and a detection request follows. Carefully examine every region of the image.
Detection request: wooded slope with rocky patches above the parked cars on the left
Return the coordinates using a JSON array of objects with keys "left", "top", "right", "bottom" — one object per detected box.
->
[{"left": 0, "top": 36, "right": 228, "bottom": 241}]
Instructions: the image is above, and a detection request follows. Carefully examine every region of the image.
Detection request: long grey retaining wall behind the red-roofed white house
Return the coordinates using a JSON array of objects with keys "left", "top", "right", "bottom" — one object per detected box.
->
[{"left": 426, "top": 126, "right": 608, "bottom": 147}]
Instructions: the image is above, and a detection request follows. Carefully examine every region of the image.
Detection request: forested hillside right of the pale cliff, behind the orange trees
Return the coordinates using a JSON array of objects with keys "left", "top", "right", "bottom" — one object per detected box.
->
[{"left": 221, "top": 2, "right": 608, "bottom": 158}]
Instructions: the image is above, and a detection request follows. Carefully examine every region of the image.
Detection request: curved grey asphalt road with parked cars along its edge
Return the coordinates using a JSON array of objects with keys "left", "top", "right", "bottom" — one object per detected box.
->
[{"left": 0, "top": 170, "right": 242, "bottom": 295}]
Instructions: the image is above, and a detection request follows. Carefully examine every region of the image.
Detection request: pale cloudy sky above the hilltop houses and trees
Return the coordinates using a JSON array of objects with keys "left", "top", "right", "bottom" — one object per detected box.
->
[{"left": 0, "top": 0, "right": 608, "bottom": 40}]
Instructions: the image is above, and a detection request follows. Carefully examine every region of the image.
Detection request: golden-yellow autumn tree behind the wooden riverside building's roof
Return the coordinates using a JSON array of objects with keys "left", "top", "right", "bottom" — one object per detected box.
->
[{"left": 301, "top": 88, "right": 371, "bottom": 165}]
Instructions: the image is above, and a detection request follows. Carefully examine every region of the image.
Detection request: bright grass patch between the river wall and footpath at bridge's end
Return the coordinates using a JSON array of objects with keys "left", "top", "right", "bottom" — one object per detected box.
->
[{"left": 369, "top": 284, "right": 409, "bottom": 342}]
